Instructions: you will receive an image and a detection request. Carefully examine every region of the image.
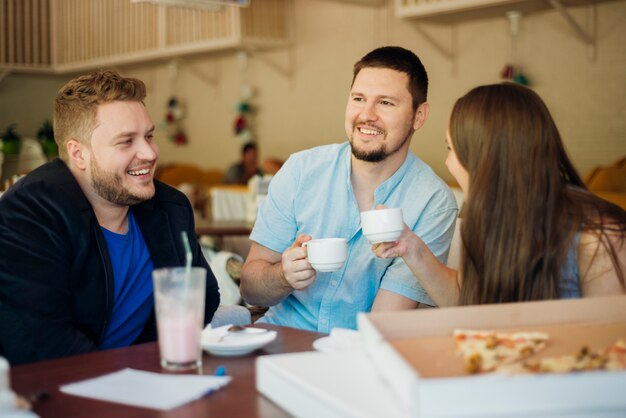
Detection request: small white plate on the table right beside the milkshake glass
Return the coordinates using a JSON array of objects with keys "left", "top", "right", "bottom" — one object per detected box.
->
[{"left": 201, "top": 326, "right": 277, "bottom": 357}]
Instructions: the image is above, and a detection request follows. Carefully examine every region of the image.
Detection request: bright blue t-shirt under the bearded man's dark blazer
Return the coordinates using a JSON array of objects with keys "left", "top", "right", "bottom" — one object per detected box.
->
[{"left": 100, "top": 211, "right": 154, "bottom": 349}]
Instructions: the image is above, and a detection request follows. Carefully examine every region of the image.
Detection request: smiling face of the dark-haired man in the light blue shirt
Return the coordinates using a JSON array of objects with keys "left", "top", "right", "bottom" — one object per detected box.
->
[{"left": 345, "top": 67, "right": 428, "bottom": 162}]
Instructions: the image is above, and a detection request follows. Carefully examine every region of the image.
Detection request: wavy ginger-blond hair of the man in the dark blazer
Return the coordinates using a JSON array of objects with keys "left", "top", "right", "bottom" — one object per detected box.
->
[{"left": 52, "top": 71, "right": 146, "bottom": 161}]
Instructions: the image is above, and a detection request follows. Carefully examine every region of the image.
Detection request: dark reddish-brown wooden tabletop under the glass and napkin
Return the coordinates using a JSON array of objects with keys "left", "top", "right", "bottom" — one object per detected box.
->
[{"left": 11, "top": 325, "right": 324, "bottom": 418}]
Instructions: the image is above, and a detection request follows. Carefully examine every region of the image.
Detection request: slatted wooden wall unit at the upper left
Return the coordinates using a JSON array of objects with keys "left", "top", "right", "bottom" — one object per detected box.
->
[{"left": 0, "top": 0, "right": 292, "bottom": 73}]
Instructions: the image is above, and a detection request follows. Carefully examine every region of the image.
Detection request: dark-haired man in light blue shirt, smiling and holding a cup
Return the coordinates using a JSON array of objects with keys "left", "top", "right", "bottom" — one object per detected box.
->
[{"left": 241, "top": 47, "right": 457, "bottom": 332}]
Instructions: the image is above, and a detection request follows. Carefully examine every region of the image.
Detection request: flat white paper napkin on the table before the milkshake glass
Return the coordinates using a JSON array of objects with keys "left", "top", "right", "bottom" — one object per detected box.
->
[{"left": 60, "top": 369, "right": 231, "bottom": 410}]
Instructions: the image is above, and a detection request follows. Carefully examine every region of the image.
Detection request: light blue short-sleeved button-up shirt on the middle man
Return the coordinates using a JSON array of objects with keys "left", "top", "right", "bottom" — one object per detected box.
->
[{"left": 250, "top": 142, "right": 457, "bottom": 332}]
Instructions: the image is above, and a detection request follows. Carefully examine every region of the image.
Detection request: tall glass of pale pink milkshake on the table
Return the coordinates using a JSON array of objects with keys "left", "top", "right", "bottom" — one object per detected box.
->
[{"left": 152, "top": 267, "right": 206, "bottom": 370}]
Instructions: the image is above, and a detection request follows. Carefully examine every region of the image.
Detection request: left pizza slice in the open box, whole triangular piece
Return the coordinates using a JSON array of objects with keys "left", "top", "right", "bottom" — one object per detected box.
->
[{"left": 453, "top": 330, "right": 549, "bottom": 373}]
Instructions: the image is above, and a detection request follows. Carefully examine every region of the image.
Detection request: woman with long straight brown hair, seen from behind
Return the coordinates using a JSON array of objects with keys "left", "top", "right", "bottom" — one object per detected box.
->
[{"left": 373, "top": 83, "right": 626, "bottom": 306}]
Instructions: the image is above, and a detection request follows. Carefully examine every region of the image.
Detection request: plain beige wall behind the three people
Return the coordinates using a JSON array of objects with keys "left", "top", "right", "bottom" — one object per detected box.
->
[{"left": 0, "top": 0, "right": 626, "bottom": 179}]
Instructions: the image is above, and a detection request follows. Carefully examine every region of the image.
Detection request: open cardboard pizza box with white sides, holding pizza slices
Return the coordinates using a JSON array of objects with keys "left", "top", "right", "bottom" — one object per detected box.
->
[{"left": 358, "top": 296, "right": 626, "bottom": 417}]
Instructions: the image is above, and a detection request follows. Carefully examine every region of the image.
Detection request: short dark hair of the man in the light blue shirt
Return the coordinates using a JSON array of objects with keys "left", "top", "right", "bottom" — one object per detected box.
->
[{"left": 352, "top": 46, "right": 428, "bottom": 110}]
